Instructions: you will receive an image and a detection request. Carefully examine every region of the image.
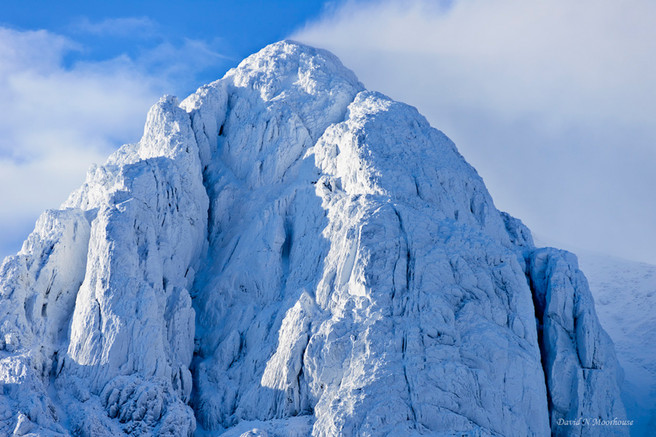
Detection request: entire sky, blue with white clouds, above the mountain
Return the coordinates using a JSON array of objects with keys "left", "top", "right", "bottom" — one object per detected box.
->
[{"left": 0, "top": 0, "right": 656, "bottom": 264}]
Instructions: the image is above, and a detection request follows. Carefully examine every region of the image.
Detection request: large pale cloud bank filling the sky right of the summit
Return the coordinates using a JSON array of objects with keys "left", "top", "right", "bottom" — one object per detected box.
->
[{"left": 292, "top": 0, "right": 656, "bottom": 262}]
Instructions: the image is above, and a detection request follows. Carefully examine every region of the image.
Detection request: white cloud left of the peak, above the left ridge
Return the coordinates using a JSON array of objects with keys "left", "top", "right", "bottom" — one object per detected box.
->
[{"left": 0, "top": 24, "right": 228, "bottom": 259}]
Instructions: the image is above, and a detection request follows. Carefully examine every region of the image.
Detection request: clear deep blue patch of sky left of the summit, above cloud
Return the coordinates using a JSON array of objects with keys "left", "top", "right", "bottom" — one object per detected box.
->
[{"left": 0, "top": 0, "right": 328, "bottom": 92}]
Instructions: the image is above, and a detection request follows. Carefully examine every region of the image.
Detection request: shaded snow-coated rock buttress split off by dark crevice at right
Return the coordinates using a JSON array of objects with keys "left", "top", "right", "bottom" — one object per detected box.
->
[{"left": 529, "top": 248, "right": 626, "bottom": 436}]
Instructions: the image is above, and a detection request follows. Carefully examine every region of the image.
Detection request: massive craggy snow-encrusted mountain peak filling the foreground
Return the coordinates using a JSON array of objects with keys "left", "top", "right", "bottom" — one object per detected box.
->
[{"left": 0, "top": 42, "right": 626, "bottom": 436}]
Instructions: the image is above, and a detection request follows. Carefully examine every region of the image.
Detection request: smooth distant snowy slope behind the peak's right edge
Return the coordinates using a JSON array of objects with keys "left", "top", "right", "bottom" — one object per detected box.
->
[{"left": 581, "top": 253, "right": 656, "bottom": 437}]
